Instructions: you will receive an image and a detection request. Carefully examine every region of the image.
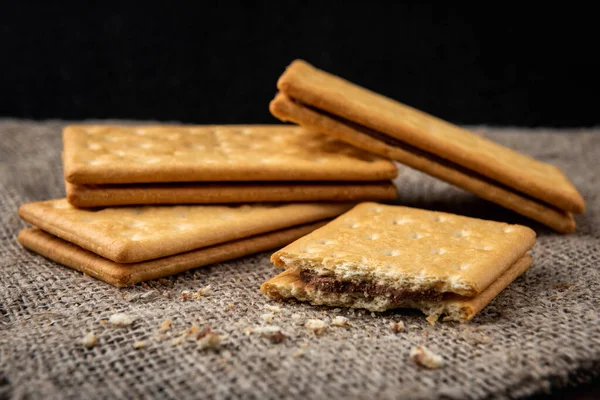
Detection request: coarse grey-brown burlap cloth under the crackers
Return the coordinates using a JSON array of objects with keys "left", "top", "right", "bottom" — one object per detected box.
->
[{"left": 0, "top": 120, "right": 600, "bottom": 399}]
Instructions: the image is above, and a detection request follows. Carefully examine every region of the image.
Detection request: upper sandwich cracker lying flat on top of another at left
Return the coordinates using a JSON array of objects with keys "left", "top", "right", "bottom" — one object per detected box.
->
[{"left": 63, "top": 125, "right": 397, "bottom": 207}]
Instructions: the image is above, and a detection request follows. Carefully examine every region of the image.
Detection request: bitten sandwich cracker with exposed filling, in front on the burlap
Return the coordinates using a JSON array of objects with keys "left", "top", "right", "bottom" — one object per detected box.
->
[{"left": 262, "top": 203, "right": 535, "bottom": 319}]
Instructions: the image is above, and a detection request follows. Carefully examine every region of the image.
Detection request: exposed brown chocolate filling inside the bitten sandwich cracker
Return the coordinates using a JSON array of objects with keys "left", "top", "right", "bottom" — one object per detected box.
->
[{"left": 300, "top": 270, "right": 444, "bottom": 304}]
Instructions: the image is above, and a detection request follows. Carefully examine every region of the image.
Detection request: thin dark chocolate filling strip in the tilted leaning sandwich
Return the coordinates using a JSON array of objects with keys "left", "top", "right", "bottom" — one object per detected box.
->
[{"left": 300, "top": 98, "right": 565, "bottom": 214}]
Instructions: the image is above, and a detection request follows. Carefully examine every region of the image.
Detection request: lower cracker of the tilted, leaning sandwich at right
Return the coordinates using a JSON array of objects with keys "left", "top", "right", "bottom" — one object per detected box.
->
[{"left": 271, "top": 93, "right": 575, "bottom": 233}]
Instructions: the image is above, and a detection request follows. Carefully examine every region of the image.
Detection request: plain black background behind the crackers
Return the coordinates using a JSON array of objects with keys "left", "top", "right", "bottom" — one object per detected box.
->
[{"left": 0, "top": 1, "right": 600, "bottom": 126}]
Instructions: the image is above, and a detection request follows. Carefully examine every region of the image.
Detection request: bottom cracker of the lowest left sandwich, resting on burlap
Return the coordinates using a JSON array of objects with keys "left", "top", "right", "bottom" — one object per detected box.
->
[{"left": 18, "top": 222, "right": 325, "bottom": 287}]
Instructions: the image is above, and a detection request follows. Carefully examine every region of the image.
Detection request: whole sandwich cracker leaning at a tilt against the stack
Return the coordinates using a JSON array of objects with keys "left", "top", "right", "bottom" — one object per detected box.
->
[{"left": 270, "top": 61, "right": 585, "bottom": 231}]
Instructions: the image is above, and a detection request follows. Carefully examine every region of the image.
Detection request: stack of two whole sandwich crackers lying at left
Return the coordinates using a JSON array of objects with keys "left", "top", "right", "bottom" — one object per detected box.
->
[{"left": 19, "top": 125, "right": 396, "bottom": 287}]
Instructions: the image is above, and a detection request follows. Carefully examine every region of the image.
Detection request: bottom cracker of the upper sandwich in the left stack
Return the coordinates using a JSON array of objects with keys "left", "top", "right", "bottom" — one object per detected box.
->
[{"left": 66, "top": 181, "right": 396, "bottom": 208}]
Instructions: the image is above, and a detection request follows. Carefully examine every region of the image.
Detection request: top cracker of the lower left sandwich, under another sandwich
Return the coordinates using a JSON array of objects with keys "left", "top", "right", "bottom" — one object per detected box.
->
[{"left": 19, "top": 199, "right": 352, "bottom": 263}]
